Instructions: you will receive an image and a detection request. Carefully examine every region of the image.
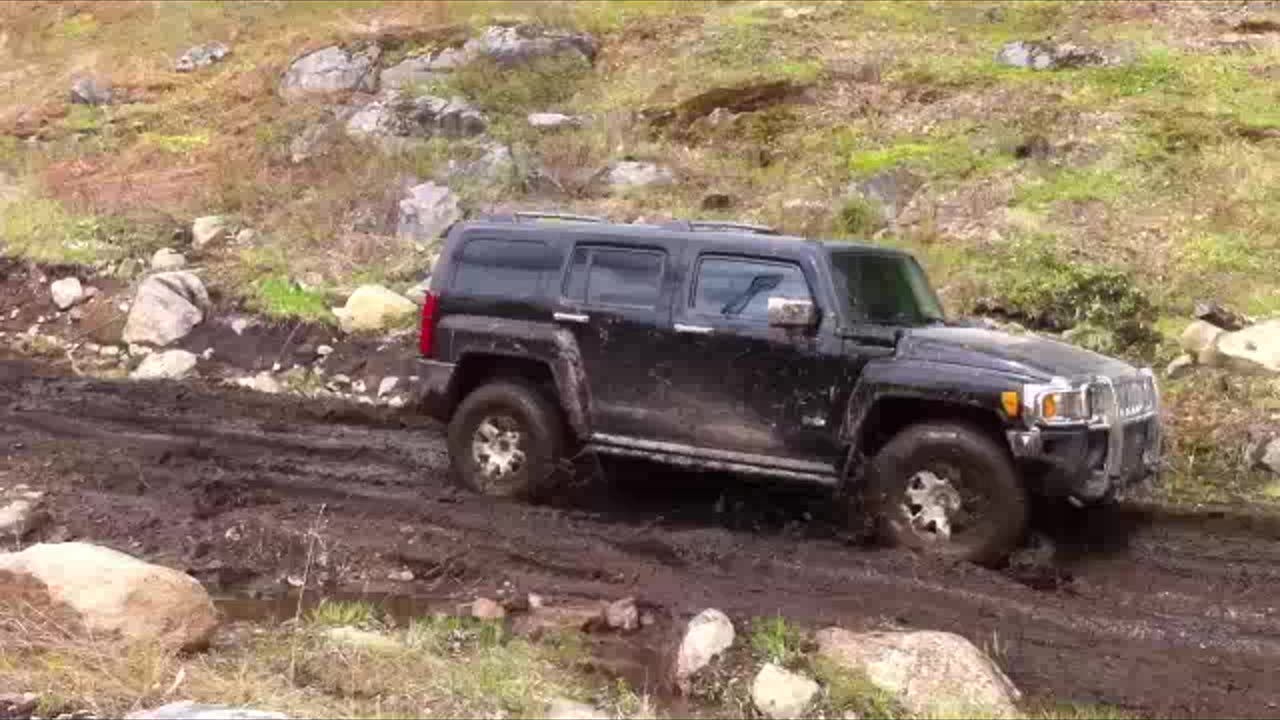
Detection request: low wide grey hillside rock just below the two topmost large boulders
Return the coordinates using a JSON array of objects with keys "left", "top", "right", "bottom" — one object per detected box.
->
[{"left": 347, "top": 91, "right": 488, "bottom": 138}]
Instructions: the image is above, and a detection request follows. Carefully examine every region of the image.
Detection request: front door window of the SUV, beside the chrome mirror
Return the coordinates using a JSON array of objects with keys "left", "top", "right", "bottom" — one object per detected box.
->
[{"left": 692, "top": 258, "right": 813, "bottom": 317}]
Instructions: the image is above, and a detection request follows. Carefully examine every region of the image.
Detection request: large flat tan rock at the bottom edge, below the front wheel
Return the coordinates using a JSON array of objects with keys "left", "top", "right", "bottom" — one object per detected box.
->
[{"left": 818, "top": 628, "right": 1021, "bottom": 717}]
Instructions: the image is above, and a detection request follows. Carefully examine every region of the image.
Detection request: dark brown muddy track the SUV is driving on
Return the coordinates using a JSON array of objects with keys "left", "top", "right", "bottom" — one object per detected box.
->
[{"left": 0, "top": 360, "right": 1280, "bottom": 716}]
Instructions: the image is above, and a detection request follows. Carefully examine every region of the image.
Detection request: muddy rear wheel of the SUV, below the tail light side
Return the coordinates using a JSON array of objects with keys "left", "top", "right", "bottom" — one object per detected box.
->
[{"left": 448, "top": 380, "right": 564, "bottom": 501}]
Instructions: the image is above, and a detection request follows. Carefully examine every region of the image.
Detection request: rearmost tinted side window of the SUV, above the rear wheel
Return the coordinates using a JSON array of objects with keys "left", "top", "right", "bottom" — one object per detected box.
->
[{"left": 453, "top": 238, "right": 559, "bottom": 297}]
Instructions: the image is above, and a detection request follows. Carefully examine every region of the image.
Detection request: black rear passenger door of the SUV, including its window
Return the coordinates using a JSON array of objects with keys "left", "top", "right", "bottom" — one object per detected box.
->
[{"left": 554, "top": 238, "right": 680, "bottom": 437}]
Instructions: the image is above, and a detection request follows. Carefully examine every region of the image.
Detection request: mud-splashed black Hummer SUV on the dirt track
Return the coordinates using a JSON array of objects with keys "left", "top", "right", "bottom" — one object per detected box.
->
[{"left": 419, "top": 214, "right": 1160, "bottom": 562}]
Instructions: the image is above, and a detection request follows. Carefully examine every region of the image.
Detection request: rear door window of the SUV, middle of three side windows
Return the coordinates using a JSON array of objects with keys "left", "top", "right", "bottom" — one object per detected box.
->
[{"left": 563, "top": 247, "right": 666, "bottom": 307}]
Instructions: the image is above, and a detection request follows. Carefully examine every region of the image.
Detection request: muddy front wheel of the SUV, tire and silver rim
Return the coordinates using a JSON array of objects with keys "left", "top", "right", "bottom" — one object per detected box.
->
[{"left": 864, "top": 423, "right": 1030, "bottom": 565}]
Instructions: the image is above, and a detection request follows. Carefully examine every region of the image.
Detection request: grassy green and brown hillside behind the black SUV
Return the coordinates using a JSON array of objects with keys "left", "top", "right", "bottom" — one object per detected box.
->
[{"left": 0, "top": 0, "right": 1280, "bottom": 498}]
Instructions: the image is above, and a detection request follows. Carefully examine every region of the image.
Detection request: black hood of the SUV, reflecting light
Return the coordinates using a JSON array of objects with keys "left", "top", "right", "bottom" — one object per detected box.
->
[{"left": 899, "top": 327, "right": 1137, "bottom": 382}]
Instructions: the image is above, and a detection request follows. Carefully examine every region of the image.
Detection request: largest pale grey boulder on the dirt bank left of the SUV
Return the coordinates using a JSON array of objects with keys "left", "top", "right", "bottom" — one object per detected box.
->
[{"left": 122, "top": 272, "right": 209, "bottom": 346}]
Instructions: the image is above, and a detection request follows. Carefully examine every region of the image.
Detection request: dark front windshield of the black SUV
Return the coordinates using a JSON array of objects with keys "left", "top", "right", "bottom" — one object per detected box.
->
[{"left": 831, "top": 252, "right": 946, "bottom": 325}]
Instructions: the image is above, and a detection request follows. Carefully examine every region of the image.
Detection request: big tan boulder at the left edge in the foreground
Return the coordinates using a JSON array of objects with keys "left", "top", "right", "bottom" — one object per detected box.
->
[{"left": 0, "top": 542, "right": 218, "bottom": 650}]
